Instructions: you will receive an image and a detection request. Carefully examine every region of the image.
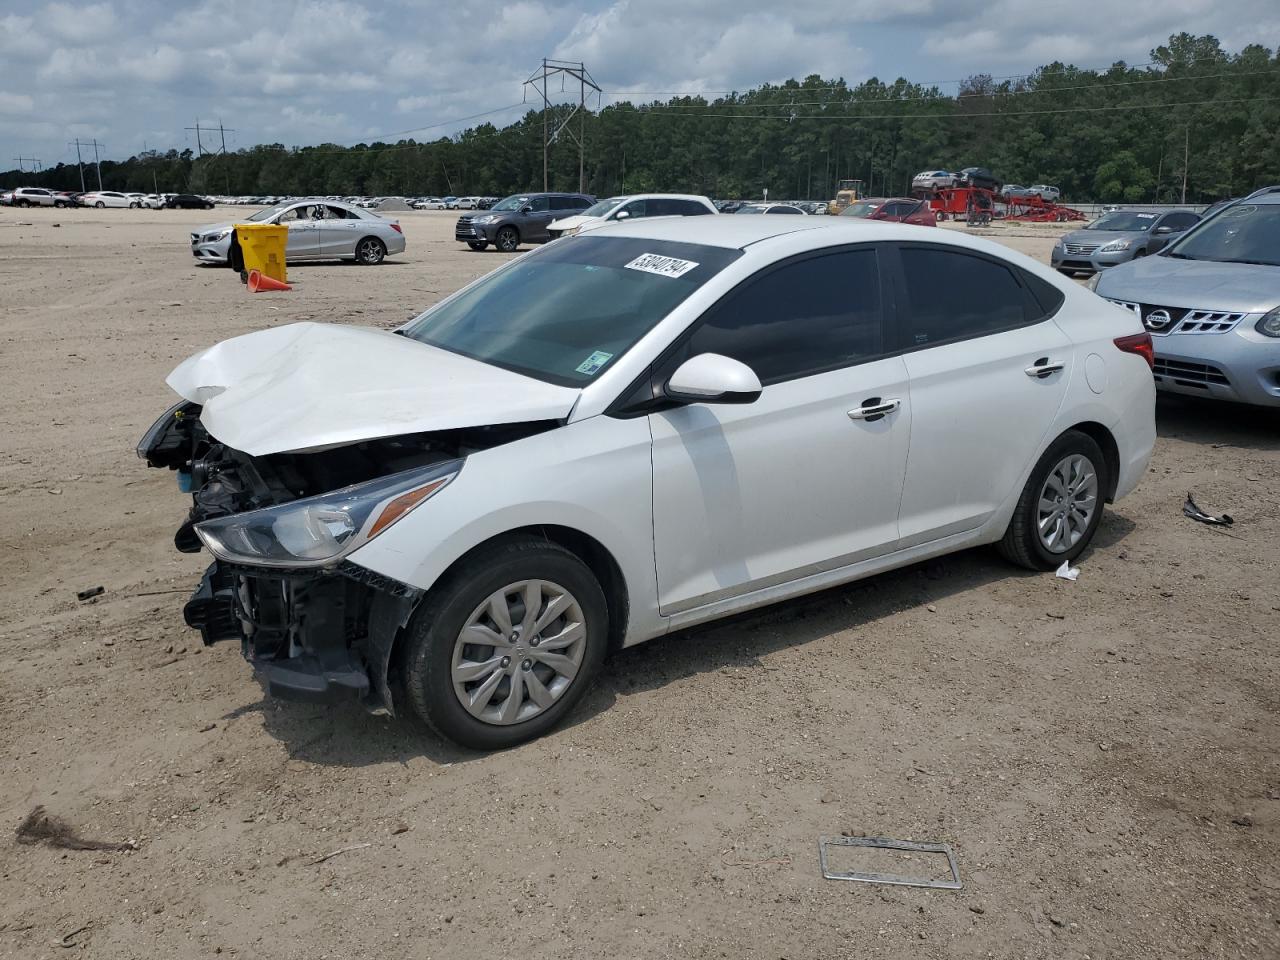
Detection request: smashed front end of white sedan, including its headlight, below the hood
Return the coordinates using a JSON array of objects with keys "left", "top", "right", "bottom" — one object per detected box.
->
[{"left": 138, "top": 403, "right": 545, "bottom": 710}]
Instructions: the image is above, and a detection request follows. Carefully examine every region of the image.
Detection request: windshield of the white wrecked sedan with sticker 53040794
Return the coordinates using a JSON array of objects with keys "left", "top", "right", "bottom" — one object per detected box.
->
[{"left": 403, "top": 236, "right": 742, "bottom": 387}]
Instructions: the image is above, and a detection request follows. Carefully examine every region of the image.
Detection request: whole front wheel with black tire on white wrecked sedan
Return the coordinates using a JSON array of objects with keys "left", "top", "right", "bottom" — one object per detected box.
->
[{"left": 402, "top": 538, "right": 609, "bottom": 750}]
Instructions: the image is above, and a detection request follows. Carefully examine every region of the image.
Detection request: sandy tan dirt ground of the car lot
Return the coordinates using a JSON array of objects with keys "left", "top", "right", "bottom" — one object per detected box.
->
[{"left": 0, "top": 204, "right": 1280, "bottom": 960}]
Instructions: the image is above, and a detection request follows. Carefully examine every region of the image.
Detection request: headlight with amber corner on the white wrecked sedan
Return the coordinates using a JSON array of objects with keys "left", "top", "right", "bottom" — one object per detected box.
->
[{"left": 196, "top": 460, "right": 462, "bottom": 567}]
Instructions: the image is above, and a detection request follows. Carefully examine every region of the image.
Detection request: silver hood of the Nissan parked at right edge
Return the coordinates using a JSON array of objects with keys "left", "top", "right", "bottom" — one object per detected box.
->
[{"left": 1097, "top": 256, "right": 1280, "bottom": 314}]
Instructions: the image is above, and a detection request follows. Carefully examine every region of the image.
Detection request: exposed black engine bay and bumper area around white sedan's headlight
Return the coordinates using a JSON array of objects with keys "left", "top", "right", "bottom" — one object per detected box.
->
[{"left": 138, "top": 402, "right": 557, "bottom": 710}]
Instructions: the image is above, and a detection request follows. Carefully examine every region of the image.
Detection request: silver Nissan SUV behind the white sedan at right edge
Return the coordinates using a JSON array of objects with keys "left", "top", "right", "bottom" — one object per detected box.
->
[{"left": 1089, "top": 188, "right": 1280, "bottom": 407}]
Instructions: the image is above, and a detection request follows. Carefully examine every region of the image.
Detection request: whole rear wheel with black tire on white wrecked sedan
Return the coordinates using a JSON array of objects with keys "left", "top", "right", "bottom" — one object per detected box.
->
[{"left": 997, "top": 430, "right": 1110, "bottom": 570}]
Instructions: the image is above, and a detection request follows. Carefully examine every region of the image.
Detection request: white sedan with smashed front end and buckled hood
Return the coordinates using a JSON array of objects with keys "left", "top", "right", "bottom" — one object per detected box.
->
[{"left": 138, "top": 216, "right": 1155, "bottom": 749}]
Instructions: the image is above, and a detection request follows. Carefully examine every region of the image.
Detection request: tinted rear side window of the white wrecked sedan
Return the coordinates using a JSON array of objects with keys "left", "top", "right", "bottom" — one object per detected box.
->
[{"left": 900, "top": 246, "right": 1044, "bottom": 349}]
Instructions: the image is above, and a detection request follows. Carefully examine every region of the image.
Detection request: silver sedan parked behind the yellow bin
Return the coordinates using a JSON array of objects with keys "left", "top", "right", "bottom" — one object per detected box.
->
[{"left": 191, "top": 200, "right": 404, "bottom": 270}]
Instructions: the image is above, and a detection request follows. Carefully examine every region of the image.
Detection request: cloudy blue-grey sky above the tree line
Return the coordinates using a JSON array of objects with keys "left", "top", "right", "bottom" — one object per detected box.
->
[{"left": 0, "top": 0, "right": 1280, "bottom": 169}]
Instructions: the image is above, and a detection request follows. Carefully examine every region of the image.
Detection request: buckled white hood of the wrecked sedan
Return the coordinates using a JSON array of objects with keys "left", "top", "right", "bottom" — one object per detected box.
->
[{"left": 165, "top": 323, "right": 579, "bottom": 457}]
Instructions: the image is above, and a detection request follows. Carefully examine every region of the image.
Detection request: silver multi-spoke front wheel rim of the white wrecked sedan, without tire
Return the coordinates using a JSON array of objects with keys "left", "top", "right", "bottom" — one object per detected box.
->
[{"left": 451, "top": 580, "right": 586, "bottom": 726}]
